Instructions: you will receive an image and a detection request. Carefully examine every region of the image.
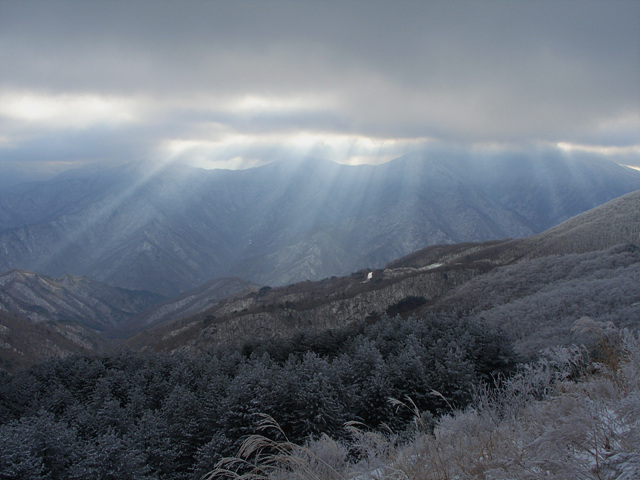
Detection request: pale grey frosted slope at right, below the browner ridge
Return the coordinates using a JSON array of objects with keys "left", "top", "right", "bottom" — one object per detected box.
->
[{"left": 431, "top": 244, "right": 640, "bottom": 356}]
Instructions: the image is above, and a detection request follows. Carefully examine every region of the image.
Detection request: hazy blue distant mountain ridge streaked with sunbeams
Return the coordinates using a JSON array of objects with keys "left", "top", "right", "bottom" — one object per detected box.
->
[{"left": 0, "top": 154, "right": 640, "bottom": 296}]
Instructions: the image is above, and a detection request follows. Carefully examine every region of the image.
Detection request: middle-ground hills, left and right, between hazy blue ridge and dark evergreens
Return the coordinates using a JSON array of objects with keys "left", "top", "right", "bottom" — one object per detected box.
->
[{"left": 0, "top": 187, "right": 640, "bottom": 368}]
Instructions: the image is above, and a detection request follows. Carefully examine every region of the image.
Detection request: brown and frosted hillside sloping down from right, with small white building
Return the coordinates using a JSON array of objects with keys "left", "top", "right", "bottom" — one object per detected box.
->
[{"left": 128, "top": 192, "right": 640, "bottom": 355}]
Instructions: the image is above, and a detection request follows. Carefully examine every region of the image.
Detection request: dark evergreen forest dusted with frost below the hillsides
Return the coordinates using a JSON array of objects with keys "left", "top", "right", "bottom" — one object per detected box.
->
[{"left": 0, "top": 316, "right": 518, "bottom": 480}]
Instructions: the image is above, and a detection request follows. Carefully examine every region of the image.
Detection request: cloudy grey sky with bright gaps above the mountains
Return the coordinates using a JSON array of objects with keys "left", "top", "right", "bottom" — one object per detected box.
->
[{"left": 0, "top": 0, "right": 640, "bottom": 182}]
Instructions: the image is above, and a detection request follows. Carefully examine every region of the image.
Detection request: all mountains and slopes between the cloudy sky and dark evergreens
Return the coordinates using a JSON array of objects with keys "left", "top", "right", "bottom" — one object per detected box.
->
[{"left": 0, "top": 152, "right": 640, "bottom": 368}]
